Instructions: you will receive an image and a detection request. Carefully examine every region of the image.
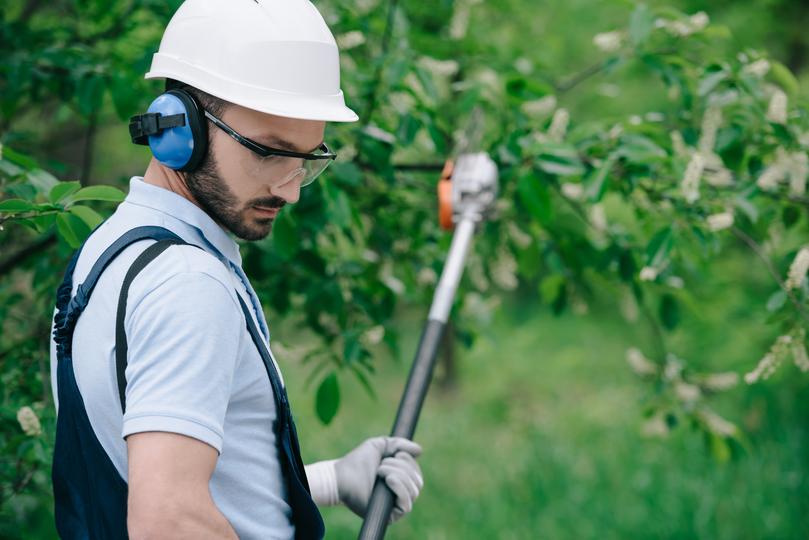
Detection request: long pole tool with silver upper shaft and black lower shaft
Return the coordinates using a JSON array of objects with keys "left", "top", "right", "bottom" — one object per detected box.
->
[{"left": 359, "top": 153, "right": 497, "bottom": 540}]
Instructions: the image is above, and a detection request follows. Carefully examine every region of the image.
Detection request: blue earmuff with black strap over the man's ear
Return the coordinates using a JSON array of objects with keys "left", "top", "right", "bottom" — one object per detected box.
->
[{"left": 129, "top": 89, "right": 208, "bottom": 172}]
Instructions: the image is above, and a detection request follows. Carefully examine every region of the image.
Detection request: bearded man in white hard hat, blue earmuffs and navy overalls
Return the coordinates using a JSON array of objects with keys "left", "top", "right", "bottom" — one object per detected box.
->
[{"left": 51, "top": 0, "right": 422, "bottom": 539}]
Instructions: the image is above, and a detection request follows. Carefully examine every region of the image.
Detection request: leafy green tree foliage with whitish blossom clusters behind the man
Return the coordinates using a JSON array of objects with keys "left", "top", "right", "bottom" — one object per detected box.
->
[{"left": 0, "top": 0, "right": 809, "bottom": 532}]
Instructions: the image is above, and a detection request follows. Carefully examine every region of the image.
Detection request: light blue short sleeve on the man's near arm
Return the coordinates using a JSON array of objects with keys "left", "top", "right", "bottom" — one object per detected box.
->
[{"left": 122, "top": 271, "right": 244, "bottom": 453}]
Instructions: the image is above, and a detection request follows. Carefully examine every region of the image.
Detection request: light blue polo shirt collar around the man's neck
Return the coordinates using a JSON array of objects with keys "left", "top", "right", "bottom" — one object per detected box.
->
[{"left": 125, "top": 176, "right": 242, "bottom": 267}]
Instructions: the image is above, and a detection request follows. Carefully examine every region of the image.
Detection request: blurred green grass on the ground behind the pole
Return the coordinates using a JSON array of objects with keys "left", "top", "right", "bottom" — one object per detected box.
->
[{"left": 288, "top": 265, "right": 809, "bottom": 539}]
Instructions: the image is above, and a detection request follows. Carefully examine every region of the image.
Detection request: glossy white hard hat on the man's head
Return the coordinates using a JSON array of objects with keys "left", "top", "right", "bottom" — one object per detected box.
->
[{"left": 146, "top": 0, "right": 358, "bottom": 122}]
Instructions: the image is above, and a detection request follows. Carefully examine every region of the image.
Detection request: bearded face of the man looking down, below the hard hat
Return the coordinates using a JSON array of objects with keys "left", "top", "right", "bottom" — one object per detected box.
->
[{"left": 186, "top": 105, "right": 326, "bottom": 240}]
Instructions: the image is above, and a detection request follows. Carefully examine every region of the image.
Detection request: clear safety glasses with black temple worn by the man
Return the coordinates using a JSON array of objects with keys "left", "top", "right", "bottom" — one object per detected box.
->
[{"left": 204, "top": 107, "right": 337, "bottom": 187}]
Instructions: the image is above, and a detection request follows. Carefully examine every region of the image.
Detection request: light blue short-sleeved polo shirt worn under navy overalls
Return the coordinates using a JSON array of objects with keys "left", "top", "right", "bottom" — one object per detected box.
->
[{"left": 51, "top": 177, "right": 295, "bottom": 539}]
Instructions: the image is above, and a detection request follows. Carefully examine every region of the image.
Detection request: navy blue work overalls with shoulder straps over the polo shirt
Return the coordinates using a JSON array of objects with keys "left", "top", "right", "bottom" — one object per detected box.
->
[{"left": 53, "top": 226, "right": 325, "bottom": 540}]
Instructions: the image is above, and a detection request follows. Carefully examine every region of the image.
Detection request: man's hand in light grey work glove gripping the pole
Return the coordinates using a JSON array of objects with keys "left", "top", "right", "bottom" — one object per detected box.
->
[{"left": 334, "top": 437, "right": 424, "bottom": 523}]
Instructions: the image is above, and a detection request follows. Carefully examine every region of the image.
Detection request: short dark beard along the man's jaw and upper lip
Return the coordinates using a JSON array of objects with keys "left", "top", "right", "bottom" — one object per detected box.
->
[{"left": 185, "top": 150, "right": 286, "bottom": 241}]
